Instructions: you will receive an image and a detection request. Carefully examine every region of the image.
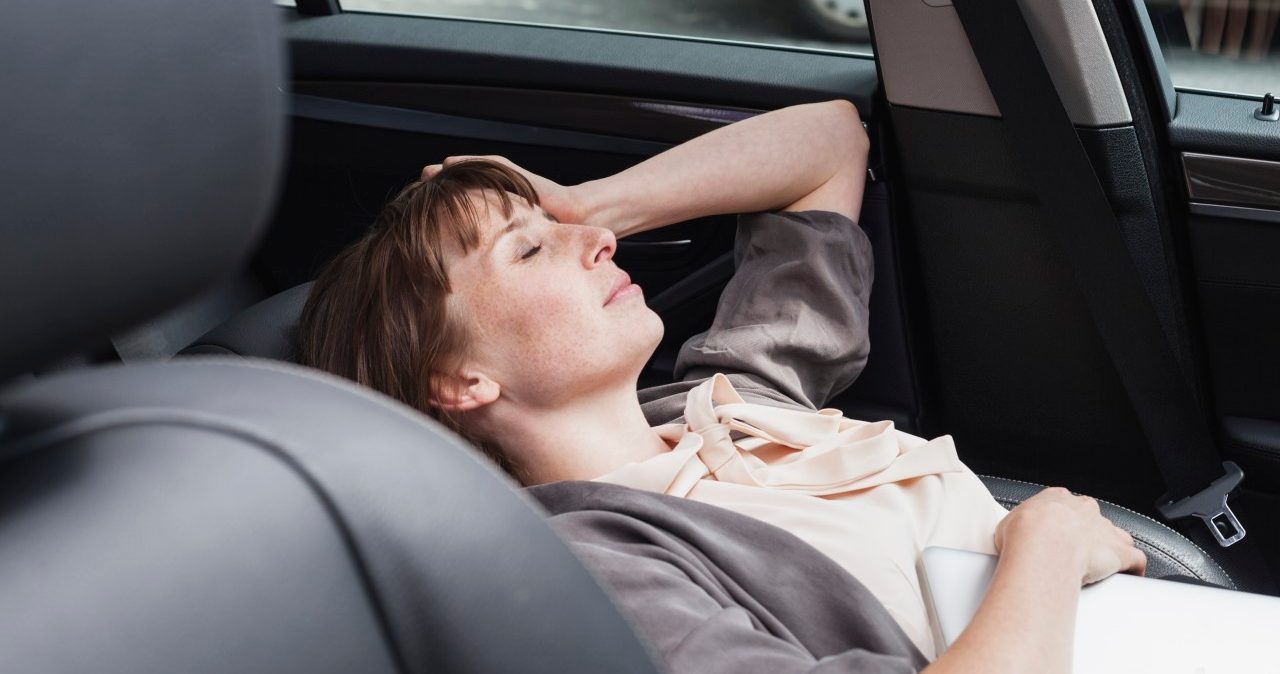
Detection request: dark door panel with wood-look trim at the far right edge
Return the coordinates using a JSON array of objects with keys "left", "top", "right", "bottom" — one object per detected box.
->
[{"left": 1170, "top": 140, "right": 1280, "bottom": 492}]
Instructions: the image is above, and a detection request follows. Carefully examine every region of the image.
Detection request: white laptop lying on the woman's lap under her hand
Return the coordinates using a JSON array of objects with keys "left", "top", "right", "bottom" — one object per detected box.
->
[{"left": 918, "top": 547, "right": 1280, "bottom": 674}]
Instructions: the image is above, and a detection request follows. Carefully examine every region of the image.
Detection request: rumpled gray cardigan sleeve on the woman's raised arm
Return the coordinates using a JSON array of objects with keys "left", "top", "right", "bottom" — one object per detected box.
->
[{"left": 675, "top": 211, "right": 874, "bottom": 409}]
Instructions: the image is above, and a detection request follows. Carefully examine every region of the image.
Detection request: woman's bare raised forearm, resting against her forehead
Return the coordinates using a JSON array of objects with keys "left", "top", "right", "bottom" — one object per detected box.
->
[{"left": 570, "top": 101, "right": 868, "bottom": 237}]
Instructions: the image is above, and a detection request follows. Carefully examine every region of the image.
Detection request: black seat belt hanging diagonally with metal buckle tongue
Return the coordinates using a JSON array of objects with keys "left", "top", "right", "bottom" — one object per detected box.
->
[{"left": 951, "top": 0, "right": 1244, "bottom": 547}]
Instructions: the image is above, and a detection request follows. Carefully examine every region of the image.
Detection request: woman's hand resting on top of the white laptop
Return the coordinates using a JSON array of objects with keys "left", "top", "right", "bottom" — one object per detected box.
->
[{"left": 995, "top": 487, "right": 1147, "bottom": 584}]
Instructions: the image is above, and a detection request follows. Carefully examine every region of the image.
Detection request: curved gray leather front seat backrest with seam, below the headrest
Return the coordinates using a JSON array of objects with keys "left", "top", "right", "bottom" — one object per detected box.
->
[{"left": 0, "top": 358, "right": 655, "bottom": 674}]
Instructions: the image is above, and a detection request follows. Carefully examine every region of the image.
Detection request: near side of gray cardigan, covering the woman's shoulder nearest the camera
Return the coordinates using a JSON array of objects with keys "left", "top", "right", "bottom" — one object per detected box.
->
[{"left": 526, "top": 481, "right": 928, "bottom": 674}]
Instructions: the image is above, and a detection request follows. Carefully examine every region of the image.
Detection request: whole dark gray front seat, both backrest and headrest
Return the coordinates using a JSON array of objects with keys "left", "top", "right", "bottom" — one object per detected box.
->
[{"left": 0, "top": 0, "right": 657, "bottom": 674}]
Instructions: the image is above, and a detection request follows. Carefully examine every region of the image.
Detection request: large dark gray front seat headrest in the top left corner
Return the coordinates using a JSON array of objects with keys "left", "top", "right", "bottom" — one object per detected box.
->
[{"left": 0, "top": 0, "right": 285, "bottom": 380}]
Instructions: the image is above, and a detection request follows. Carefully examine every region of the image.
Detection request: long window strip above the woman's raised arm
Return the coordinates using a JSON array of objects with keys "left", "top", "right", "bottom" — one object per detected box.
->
[{"left": 342, "top": 0, "right": 872, "bottom": 54}]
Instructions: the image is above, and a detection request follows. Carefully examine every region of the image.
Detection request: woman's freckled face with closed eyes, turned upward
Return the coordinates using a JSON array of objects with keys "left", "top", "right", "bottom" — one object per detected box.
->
[{"left": 448, "top": 189, "right": 663, "bottom": 407}]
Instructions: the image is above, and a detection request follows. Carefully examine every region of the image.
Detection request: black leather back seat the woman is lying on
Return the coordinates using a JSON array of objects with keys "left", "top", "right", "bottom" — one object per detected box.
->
[{"left": 182, "top": 283, "right": 1236, "bottom": 590}]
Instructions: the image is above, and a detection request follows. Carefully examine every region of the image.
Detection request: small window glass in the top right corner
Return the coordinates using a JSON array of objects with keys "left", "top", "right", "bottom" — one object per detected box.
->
[{"left": 1146, "top": 0, "right": 1280, "bottom": 96}]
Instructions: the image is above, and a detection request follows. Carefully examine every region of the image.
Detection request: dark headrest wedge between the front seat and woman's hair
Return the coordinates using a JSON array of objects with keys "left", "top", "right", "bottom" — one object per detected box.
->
[{"left": 179, "top": 283, "right": 312, "bottom": 363}]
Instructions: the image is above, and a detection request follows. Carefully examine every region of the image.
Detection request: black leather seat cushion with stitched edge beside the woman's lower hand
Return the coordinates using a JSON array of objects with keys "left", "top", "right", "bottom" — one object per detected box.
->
[{"left": 980, "top": 476, "right": 1236, "bottom": 590}]
